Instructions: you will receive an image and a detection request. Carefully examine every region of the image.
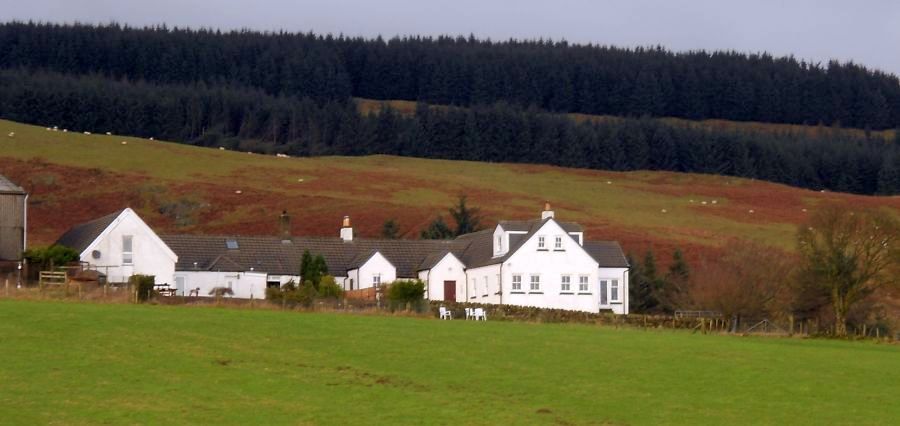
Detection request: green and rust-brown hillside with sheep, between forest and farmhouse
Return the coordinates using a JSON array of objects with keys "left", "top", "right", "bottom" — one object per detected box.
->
[{"left": 0, "top": 121, "right": 900, "bottom": 266}]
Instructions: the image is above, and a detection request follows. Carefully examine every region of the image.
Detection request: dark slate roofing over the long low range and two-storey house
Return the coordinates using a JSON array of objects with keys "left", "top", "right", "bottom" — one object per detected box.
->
[{"left": 160, "top": 219, "right": 627, "bottom": 278}]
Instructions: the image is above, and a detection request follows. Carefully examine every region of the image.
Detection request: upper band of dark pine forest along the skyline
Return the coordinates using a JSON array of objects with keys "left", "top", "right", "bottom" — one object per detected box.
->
[{"left": 0, "top": 22, "right": 900, "bottom": 129}]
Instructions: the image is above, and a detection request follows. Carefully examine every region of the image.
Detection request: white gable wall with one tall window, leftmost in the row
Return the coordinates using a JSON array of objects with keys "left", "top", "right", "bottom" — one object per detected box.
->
[{"left": 81, "top": 209, "right": 178, "bottom": 284}]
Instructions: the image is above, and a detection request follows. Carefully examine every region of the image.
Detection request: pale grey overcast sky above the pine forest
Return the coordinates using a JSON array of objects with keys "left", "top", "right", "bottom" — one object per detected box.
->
[{"left": 0, "top": 0, "right": 900, "bottom": 74}]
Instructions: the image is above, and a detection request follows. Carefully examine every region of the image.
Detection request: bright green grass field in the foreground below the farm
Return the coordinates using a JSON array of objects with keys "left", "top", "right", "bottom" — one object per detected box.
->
[{"left": 0, "top": 300, "right": 900, "bottom": 424}]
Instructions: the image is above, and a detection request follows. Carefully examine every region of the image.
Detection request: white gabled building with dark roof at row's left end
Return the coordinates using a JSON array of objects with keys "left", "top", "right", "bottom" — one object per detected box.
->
[{"left": 56, "top": 208, "right": 178, "bottom": 284}]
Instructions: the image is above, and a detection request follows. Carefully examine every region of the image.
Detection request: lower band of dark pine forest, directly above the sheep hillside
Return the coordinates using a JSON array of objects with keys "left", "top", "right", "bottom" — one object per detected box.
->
[{"left": 0, "top": 70, "right": 900, "bottom": 194}]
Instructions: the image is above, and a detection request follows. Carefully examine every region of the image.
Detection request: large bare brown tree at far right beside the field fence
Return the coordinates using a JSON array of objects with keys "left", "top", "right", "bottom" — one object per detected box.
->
[{"left": 797, "top": 206, "right": 900, "bottom": 336}]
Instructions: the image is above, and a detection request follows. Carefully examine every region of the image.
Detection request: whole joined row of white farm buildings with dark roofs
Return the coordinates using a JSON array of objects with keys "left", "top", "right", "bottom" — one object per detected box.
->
[{"left": 59, "top": 204, "right": 628, "bottom": 314}]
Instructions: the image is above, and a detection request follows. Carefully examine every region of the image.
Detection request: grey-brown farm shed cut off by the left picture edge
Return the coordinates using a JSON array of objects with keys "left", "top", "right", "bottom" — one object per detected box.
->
[{"left": 0, "top": 176, "right": 28, "bottom": 262}]
